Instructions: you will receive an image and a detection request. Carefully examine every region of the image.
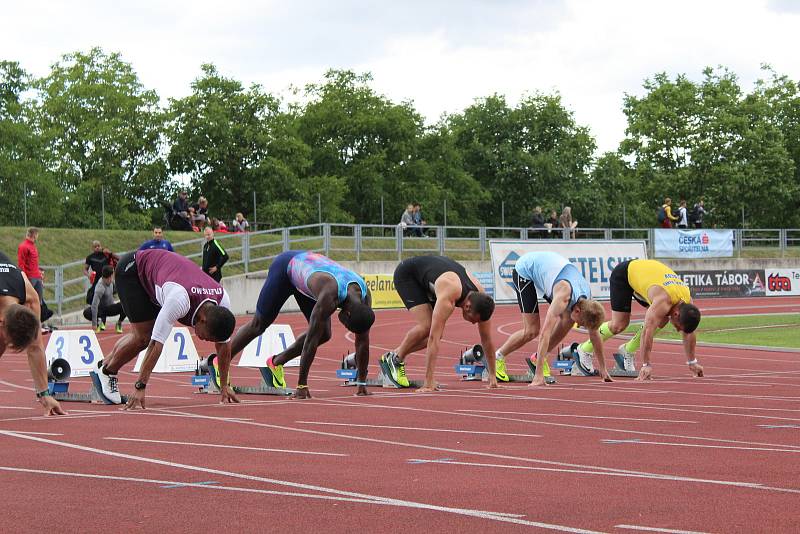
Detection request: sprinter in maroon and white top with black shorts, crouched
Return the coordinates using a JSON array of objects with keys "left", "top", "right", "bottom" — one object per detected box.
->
[{"left": 91, "top": 249, "right": 239, "bottom": 409}]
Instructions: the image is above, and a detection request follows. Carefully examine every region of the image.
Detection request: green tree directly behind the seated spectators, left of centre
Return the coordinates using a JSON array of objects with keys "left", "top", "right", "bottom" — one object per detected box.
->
[{"left": 169, "top": 64, "right": 322, "bottom": 226}]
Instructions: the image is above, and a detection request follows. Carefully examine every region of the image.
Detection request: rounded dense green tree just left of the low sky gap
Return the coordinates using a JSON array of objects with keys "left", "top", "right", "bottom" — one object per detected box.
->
[{"left": 448, "top": 94, "right": 595, "bottom": 226}]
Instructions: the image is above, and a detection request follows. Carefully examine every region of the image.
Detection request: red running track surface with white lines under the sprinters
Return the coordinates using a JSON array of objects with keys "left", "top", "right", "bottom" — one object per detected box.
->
[{"left": 0, "top": 298, "right": 800, "bottom": 532}]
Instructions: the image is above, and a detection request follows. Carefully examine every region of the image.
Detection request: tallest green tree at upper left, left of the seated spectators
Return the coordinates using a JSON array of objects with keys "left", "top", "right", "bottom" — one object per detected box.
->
[{"left": 36, "top": 48, "right": 166, "bottom": 228}]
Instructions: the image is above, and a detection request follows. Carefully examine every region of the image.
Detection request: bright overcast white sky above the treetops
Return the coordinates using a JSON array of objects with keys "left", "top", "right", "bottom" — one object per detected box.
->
[{"left": 0, "top": 0, "right": 800, "bottom": 155}]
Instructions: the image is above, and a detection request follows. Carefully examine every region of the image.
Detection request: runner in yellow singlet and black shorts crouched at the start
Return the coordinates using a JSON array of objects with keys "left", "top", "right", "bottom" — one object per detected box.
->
[{"left": 578, "top": 260, "right": 703, "bottom": 380}]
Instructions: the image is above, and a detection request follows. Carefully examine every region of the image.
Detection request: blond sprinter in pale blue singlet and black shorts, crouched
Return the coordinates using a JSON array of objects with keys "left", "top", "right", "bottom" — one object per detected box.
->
[{"left": 496, "top": 251, "right": 611, "bottom": 386}]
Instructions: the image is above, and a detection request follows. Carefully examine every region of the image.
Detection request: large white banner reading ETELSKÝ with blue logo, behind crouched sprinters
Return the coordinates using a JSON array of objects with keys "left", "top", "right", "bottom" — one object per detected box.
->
[{"left": 489, "top": 240, "right": 647, "bottom": 303}]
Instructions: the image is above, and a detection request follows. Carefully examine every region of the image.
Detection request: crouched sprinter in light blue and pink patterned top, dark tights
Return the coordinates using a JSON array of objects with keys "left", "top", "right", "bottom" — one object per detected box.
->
[{"left": 231, "top": 250, "right": 375, "bottom": 399}]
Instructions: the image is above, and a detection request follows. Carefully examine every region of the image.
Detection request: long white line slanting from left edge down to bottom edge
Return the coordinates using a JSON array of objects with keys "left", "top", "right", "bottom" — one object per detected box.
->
[{"left": 0, "top": 434, "right": 595, "bottom": 534}]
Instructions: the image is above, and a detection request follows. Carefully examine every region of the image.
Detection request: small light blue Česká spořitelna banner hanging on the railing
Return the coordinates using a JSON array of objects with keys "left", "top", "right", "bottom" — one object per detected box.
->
[{"left": 655, "top": 228, "right": 733, "bottom": 258}]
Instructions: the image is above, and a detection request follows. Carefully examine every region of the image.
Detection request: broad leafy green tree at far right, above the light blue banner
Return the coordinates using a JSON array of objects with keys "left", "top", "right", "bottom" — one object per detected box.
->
[{"left": 621, "top": 68, "right": 798, "bottom": 227}]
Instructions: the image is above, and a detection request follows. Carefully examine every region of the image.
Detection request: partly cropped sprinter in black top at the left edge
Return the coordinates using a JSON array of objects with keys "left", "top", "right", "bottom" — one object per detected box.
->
[{"left": 0, "top": 252, "right": 66, "bottom": 415}]
